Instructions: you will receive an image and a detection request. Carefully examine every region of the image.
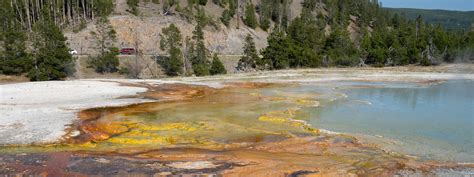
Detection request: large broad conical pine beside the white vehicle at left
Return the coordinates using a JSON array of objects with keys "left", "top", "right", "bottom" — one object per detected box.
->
[{"left": 28, "top": 8, "right": 75, "bottom": 81}]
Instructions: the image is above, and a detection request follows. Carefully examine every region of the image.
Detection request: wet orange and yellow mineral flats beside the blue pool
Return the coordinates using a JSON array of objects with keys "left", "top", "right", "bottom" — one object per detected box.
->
[{"left": 0, "top": 82, "right": 474, "bottom": 176}]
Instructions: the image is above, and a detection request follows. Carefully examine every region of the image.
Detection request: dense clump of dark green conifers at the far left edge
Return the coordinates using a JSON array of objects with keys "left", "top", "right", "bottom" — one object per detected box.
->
[{"left": 0, "top": 1, "right": 74, "bottom": 81}]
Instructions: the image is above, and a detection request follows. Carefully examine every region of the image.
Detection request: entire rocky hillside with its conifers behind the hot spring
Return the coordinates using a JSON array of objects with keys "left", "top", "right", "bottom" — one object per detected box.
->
[{"left": 0, "top": 0, "right": 474, "bottom": 80}]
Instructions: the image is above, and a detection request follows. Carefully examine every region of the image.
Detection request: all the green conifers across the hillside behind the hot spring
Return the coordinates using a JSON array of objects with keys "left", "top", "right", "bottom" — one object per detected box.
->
[{"left": 0, "top": 0, "right": 474, "bottom": 80}]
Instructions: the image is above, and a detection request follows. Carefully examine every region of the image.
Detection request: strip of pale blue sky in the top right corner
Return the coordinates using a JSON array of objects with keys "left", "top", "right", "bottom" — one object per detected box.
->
[{"left": 379, "top": 0, "right": 474, "bottom": 11}]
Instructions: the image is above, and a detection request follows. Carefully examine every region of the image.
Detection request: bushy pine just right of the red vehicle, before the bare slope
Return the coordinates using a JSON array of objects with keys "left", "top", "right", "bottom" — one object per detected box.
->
[{"left": 160, "top": 23, "right": 184, "bottom": 76}]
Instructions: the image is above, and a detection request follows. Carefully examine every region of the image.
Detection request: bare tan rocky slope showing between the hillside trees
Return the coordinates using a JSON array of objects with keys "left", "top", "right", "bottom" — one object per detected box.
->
[{"left": 65, "top": 0, "right": 322, "bottom": 55}]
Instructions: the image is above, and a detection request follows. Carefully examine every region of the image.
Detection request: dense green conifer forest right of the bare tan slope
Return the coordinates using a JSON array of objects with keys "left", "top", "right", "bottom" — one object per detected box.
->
[{"left": 237, "top": 0, "right": 474, "bottom": 71}]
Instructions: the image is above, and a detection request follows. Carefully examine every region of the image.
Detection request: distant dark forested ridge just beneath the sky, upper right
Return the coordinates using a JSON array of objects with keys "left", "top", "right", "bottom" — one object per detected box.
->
[{"left": 386, "top": 8, "right": 474, "bottom": 30}]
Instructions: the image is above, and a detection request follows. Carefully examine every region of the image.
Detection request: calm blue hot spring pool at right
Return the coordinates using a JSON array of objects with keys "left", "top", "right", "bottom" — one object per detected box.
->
[{"left": 300, "top": 81, "right": 474, "bottom": 163}]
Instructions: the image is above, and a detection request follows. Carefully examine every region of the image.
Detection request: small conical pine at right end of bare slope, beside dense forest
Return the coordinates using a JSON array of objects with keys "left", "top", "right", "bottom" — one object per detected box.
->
[{"left": 237, "top": 34, "right": 260, "bottom": 71}]
